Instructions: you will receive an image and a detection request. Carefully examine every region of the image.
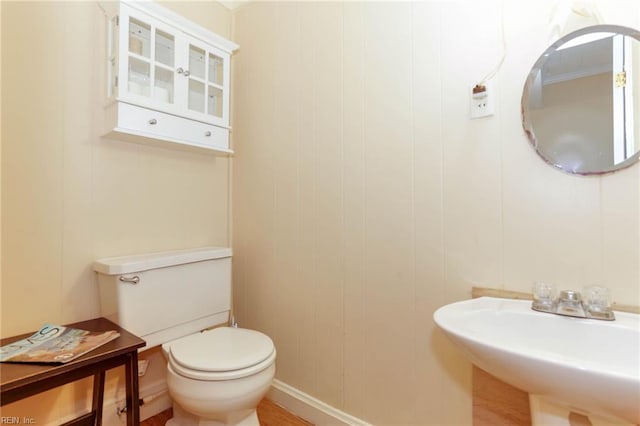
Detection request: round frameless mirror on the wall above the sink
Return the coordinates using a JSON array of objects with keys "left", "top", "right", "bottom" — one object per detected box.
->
[{"left": 522, "top": 25, "right": 640, "bottom": 175}]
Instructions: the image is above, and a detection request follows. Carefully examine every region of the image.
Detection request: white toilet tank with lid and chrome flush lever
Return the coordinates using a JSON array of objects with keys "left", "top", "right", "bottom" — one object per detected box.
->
[{"left": 93, "top": 247, "right": 231, "bottom": 349}]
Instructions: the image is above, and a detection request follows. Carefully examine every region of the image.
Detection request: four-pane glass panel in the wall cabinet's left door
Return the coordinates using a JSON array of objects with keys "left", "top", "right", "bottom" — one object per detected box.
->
[{"left": 127, "top": 17, "right": 176, "bottom": 104}]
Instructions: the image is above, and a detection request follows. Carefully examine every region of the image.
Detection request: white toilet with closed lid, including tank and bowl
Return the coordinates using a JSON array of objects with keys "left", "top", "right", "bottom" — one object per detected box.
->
[{"left": 94, "top": 247, "right": 276, "bottom": 426}]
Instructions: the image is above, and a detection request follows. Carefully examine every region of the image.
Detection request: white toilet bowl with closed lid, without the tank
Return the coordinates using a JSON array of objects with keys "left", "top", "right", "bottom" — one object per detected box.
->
[{"left": 162, "top": 327, "right": 276, "bottom": 426}]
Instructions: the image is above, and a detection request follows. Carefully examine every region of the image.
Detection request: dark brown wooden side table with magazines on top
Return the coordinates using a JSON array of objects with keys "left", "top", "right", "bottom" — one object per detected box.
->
[{"left": 0, "top": 318, "right": 145, "bottom": 426}]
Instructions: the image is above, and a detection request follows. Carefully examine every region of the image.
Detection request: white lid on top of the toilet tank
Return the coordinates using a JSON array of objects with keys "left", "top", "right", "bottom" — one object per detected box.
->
[{"left": 93, "top": 247, "right": 232, "bottom": 275}]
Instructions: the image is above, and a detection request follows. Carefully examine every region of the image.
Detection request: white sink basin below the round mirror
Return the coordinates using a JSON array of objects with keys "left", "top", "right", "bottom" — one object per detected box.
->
[{"left": 434, "top": 297, "right": 640, "bottom": 424}]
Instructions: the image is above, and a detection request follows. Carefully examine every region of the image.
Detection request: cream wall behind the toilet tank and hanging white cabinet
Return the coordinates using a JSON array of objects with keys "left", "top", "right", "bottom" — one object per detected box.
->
[{"left": 1, "top": 1, "right": 231, "bottom": 424}]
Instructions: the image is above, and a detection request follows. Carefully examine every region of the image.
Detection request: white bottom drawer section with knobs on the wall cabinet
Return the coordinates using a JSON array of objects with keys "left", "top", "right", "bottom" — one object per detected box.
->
[{"left": 111, "top": 102, "right": 232, "bottom": 153}]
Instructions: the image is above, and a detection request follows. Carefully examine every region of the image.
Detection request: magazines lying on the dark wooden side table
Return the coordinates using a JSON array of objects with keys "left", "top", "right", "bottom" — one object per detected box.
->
[{"left": 0, "top": 324, "right": 120, "bottom": 363}]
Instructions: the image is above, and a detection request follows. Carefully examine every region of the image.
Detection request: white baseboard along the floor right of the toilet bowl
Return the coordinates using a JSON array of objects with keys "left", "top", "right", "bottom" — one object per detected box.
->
[{"left": 267, "top": 379, "right": 371, "bottom": 426}]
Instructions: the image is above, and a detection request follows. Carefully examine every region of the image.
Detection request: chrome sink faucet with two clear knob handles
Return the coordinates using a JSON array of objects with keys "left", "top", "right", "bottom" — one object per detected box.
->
[{"left": 531, "top": 283, "right": 616, "bottom": 321}]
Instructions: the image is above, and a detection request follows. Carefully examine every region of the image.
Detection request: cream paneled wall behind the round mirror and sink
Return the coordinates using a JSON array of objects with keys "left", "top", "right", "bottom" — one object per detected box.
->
[{"left": 232, "top": 0, "right": 640, "bottom": 425}]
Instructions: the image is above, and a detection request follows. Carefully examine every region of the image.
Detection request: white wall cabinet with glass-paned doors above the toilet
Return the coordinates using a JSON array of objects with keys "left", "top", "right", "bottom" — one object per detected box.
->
[{"left": 104, "top": 1, "right": 238, "bottom": 153}]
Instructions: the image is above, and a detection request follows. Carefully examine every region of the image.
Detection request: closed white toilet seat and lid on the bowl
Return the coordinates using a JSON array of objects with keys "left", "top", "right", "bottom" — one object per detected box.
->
[{"left": 166, "top": 327, "right": 276, "bottom": 381}]
